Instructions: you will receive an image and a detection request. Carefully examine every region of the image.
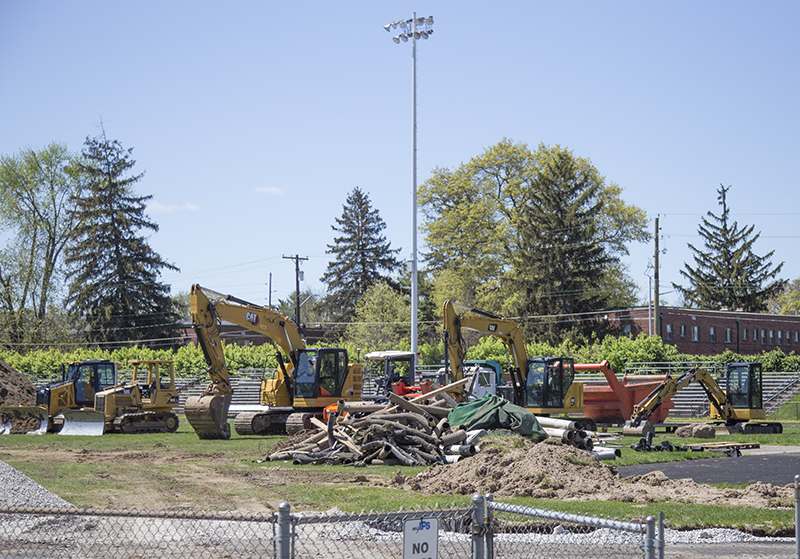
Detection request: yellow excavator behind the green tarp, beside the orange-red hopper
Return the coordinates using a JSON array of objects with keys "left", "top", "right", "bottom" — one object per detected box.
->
[{"left": 443, "top": 299, "right": 594, "bottom": 424}]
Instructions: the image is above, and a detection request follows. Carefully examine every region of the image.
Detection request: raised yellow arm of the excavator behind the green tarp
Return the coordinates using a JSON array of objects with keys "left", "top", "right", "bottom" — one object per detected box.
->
[{"left": 442, "top": 299, "right": 528, "bottom": 402}]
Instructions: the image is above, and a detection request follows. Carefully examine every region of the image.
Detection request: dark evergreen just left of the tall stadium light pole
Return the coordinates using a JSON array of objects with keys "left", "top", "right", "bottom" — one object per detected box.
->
[{"left": 321, "top": 187, "right": 402, "bottom": 322}]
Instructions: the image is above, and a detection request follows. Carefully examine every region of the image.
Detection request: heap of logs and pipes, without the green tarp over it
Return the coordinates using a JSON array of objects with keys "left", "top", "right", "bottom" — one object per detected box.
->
[{"left": 267, "top": 379, "right": 593, "bottom": 466}]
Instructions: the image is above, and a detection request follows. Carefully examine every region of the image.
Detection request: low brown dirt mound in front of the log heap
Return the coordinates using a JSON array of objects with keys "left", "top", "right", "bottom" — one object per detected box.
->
[{"left": 389, "top": 439, "right": 794, "bottom": 508}]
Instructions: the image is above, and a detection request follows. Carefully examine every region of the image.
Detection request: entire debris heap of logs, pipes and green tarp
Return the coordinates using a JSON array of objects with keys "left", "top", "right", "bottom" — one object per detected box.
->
[{"left": 267, "top": 385, "right": 594, "bottom": 466}]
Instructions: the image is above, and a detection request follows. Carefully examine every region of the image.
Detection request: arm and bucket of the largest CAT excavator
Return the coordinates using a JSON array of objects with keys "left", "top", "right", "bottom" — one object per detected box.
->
[{"left": 184, "top": 284, "right": 305, "bottom": 439}]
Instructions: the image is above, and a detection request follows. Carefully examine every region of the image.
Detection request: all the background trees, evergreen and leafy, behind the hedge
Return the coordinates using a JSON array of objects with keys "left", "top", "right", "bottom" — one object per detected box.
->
[{"left": 0, "top": 135, "right": 788, "bottom": 350}]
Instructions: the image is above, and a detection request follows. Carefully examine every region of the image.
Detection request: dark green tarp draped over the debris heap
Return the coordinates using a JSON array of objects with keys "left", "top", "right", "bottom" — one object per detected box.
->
[{"left": 447, "top": 394, "right": 547, "bottom": 437}]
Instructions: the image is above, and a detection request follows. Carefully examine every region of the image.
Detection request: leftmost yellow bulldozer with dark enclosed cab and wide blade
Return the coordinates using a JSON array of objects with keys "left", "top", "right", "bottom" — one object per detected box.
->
[{"left": 0, "top": 361, "right": 118, "bottom": 435}]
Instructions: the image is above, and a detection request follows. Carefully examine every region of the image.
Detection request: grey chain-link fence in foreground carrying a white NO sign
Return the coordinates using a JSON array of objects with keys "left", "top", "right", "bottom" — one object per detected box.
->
[{"left": 0, "top": 495, "right": 663, "bottom": 559}]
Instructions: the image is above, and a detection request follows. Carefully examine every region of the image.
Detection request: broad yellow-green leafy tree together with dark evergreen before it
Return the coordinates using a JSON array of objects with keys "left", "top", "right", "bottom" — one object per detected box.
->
[{"left": 420, "top": 139, "right": 650, "bottom": 342}]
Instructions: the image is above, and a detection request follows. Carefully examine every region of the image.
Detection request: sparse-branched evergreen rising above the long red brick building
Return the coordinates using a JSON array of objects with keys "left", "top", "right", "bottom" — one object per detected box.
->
[{"left": 672, "top": 185, "right": 786, "bottom": 312}]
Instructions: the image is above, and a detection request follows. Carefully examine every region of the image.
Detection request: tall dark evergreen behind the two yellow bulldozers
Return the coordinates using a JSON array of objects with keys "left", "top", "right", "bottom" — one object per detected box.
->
[{"left": 65, "top": 132, "right": 179, "bottom": 344}]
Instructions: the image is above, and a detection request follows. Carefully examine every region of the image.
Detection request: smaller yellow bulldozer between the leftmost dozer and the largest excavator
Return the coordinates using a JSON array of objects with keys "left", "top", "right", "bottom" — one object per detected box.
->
[{"left": 94, "top": 360, "right": 179, "bottom": 434}]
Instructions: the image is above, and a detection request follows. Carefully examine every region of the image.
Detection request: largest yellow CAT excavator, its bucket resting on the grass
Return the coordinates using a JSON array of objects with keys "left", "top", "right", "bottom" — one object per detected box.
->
[{"left": 184, "top": 284, "right": 364, "bottom": 439}]
